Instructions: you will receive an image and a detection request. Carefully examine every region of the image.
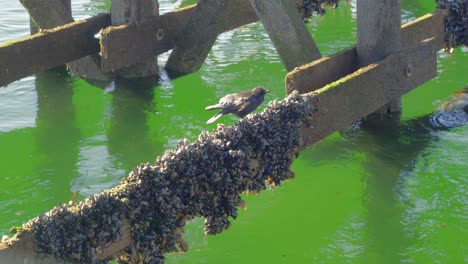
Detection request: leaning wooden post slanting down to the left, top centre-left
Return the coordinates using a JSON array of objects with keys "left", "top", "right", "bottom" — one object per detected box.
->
[{"left": 166, "top": 0, "right": 232, "bottom": 75}]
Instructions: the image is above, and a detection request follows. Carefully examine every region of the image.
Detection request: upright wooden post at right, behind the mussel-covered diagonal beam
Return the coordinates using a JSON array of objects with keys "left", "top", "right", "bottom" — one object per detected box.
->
[{"left": 357, "top": 0, "right": 401, "bottom": 113}]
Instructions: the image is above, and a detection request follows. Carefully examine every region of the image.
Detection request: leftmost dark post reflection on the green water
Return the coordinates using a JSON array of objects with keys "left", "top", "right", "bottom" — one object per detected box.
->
[{"left": 36, "top": 68, "right": 80, "bottom": 201}]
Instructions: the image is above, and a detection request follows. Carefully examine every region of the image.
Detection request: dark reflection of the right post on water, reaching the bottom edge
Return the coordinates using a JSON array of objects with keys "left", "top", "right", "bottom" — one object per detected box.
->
[{"left": 343, "top": 89, "right": 468, "bottom": 263}]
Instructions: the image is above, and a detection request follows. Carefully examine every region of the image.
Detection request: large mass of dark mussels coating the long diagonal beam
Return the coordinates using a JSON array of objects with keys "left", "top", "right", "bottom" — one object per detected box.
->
[{"left": 14, "top": 92, "right": 313, "bottom": 263}]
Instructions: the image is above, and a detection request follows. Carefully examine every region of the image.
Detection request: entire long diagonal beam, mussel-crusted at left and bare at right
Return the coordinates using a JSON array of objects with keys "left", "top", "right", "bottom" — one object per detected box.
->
[{"left": 0, "top": 41, "right": 436, "bottom": 263}]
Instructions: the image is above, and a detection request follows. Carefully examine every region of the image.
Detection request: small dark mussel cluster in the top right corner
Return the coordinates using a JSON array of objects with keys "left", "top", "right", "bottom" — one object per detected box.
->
[{"left": 436, "top": 0, "right": 468, "bottom": 52}]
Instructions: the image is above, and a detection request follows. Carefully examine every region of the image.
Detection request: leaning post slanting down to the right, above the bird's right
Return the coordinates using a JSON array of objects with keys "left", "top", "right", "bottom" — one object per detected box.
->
[{"left": 249, "top": 0, "right": 322, "bottom": 71}]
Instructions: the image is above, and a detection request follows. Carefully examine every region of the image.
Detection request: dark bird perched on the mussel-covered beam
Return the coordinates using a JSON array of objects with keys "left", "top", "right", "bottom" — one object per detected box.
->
[{"left": 205, "top": 86, "right": 270, "bottom": 124}]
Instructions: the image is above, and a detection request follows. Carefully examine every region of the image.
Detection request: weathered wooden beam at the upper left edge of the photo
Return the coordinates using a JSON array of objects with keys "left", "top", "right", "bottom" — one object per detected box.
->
[{"left": 0, "top": 14, "right": 110, "bottom": 86}]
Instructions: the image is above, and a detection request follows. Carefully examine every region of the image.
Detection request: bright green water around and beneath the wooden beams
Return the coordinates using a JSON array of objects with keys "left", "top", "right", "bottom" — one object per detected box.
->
[{"left": 0, "top": 0, "right": 468, "bottom": 263}]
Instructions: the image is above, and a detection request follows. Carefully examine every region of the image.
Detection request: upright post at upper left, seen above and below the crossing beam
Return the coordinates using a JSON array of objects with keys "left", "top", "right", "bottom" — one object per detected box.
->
[{"left": 111, "top": 0, "right": 159, "bottom": 78}]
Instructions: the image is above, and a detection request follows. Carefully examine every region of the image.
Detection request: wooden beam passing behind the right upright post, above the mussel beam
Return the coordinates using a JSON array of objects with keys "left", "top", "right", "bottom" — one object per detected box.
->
[{"left": 286, "top": 10, "right": 447, "bottom": 94}]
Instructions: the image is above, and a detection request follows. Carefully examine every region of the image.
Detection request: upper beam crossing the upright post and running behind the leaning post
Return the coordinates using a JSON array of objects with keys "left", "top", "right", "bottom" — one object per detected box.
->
[{"left": 101, "top": 0, "right": 258, "bottom": 71}]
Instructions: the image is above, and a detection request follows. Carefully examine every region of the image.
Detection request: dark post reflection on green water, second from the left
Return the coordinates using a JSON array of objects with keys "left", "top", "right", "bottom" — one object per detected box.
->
[{"left": 106, "top": 76, "right": 162, "bottom": 171}]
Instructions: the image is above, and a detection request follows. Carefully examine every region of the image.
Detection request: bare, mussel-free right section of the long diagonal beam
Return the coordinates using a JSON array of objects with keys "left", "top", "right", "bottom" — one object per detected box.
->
[{"left": 302, "top": 39, "right": 437, "bottom": 147}]
